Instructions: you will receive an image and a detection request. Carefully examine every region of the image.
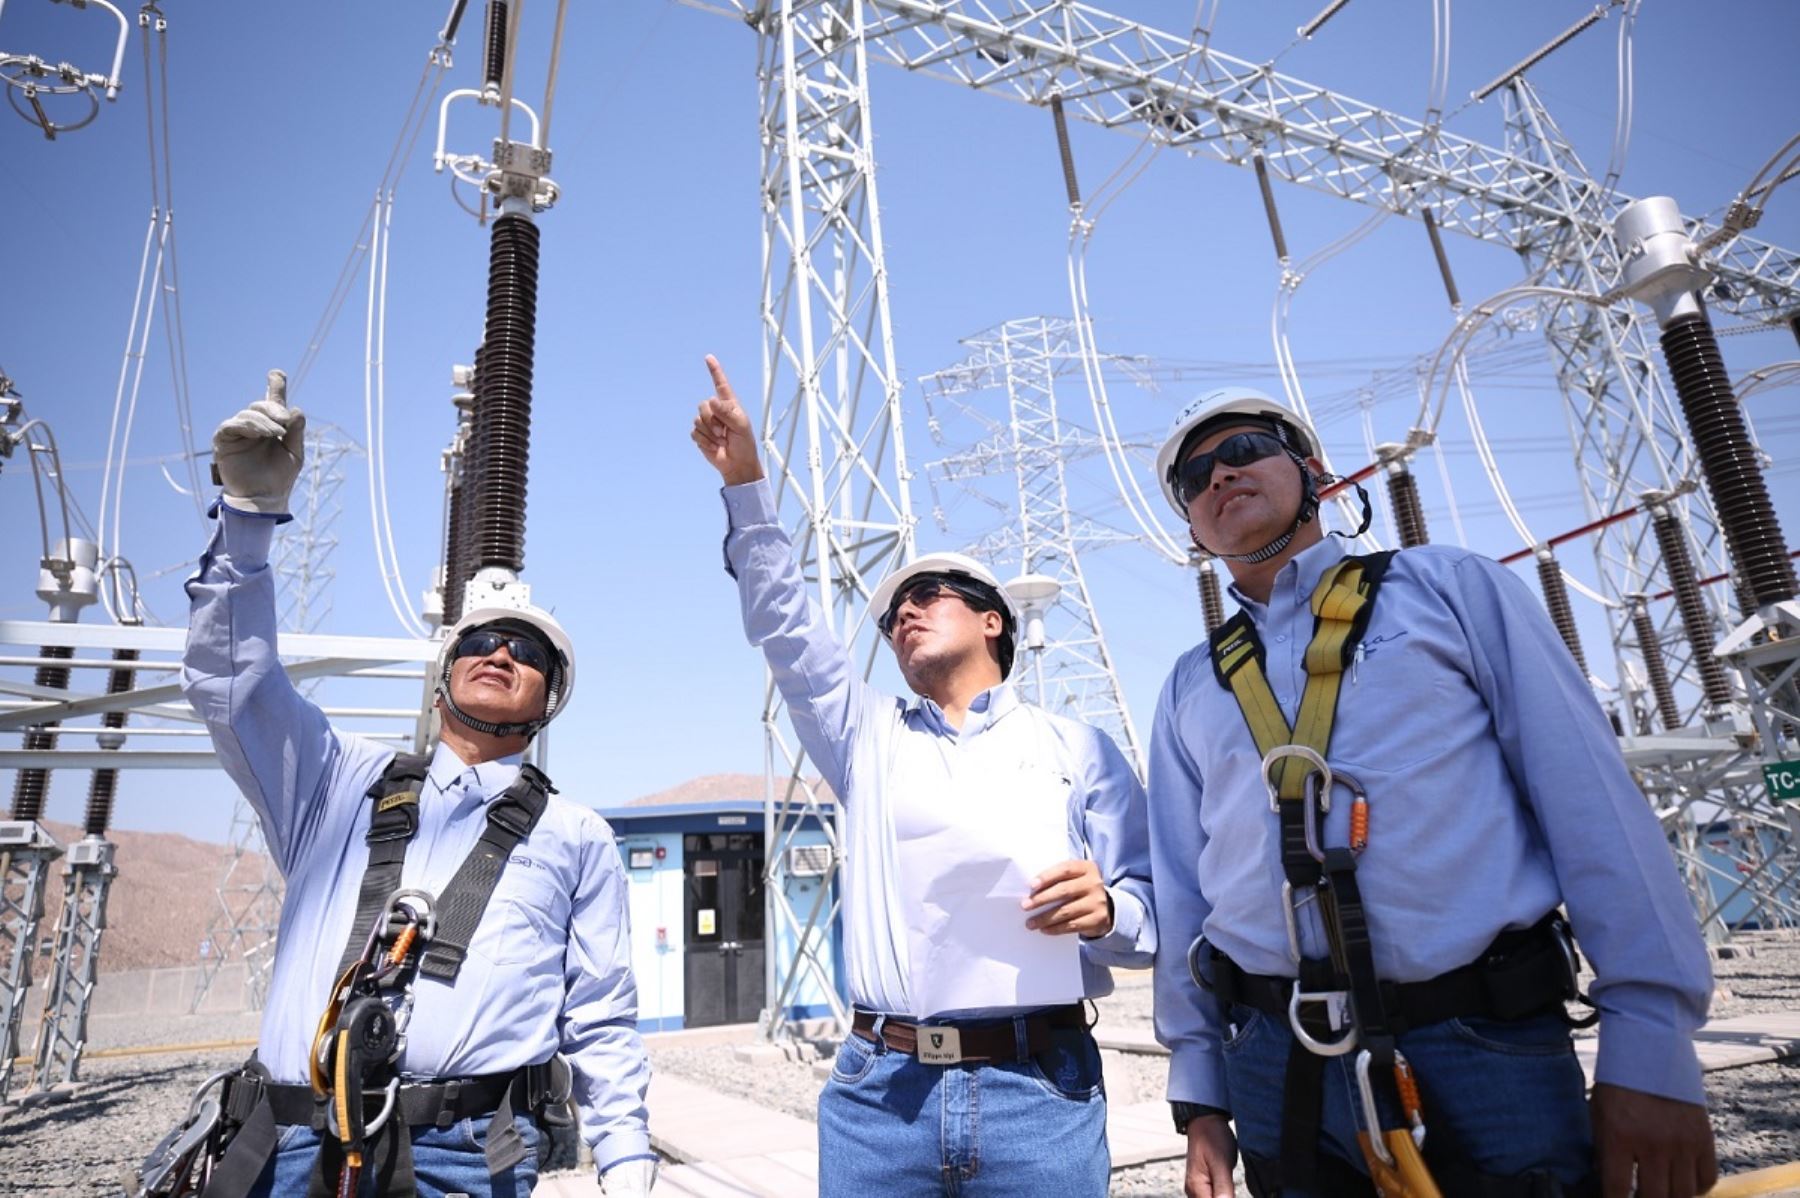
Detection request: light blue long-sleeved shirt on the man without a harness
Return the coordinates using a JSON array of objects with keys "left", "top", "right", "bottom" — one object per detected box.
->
[{"left": 724, "top": 480, "right": 1156, "bottom": 1018}]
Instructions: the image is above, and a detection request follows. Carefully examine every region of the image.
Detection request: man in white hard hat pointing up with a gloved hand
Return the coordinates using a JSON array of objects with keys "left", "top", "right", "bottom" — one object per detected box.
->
[{"left": 165, "top": 371, "right": 655, "bottom": 1198}]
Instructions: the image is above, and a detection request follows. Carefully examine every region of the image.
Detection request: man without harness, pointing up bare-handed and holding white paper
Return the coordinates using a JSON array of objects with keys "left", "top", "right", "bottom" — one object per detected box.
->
[{"left": 693, "top": 358, "right": 1156, "bottom": 1198}]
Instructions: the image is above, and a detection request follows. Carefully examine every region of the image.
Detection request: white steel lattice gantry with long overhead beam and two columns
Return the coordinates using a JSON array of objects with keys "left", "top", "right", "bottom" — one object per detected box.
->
[{"left": 734, "top": 0, "right": 1800, "bottom": 1036}]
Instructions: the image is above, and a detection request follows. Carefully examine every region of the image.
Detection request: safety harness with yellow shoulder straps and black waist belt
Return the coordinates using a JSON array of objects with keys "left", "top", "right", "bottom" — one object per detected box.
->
[{"left": 1190, "top": 550, "right": 1577, "bottom": 1198}]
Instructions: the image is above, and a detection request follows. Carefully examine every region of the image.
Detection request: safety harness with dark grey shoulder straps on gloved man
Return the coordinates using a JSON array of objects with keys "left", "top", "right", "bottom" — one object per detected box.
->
[{"left": 137, "top": 754, "right": 571, "bottom": 1198}]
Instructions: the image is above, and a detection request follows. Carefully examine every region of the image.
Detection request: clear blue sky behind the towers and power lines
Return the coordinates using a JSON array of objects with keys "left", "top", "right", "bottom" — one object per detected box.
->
[{"left": 0, "top": 0, "right": 1800, "bottom": 838}]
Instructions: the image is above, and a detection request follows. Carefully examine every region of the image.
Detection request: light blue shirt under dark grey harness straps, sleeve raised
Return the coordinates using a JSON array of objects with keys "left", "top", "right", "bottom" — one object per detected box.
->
[{"left": 182, "top": 509, "right": 650, "bottom": 1173}]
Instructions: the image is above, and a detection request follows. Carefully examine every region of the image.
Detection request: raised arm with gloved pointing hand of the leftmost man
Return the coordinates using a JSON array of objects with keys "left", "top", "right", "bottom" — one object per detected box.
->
[{"left": 182, "top": 371, "right": 373, "bottom": 872}]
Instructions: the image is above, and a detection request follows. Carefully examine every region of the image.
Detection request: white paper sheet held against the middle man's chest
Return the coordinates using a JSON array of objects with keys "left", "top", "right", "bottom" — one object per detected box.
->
[{"left": 902, "top": 766, "right": 1082, "bottom": 1016}]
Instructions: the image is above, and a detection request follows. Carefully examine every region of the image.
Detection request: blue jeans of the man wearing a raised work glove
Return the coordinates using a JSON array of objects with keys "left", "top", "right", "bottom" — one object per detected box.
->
[{"left": 250, "top": 1115, "right": 544, "bottom": 1198}]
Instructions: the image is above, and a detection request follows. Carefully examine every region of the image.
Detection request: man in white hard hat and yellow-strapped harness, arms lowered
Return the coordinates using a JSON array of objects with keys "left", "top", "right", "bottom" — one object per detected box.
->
[{"left": 1150, "top": 387, "right": 1715, "bottom": 1198}]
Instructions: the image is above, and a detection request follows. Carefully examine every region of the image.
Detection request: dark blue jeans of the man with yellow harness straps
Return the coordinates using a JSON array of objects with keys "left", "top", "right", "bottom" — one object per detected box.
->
[{"left": 1224, "top": 1006, "right": 1593, "bottom": 1198}]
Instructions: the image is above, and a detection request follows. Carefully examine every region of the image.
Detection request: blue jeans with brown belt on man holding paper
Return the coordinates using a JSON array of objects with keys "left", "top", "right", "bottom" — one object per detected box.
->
[{"left": 819, "top": 1020, "right": 1111, "bottom": 1198}]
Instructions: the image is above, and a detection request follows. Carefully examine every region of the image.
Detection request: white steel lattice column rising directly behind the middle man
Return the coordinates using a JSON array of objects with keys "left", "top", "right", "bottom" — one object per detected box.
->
[{"left": 745, "top": 0, "right": 914, "bottom": 1038}]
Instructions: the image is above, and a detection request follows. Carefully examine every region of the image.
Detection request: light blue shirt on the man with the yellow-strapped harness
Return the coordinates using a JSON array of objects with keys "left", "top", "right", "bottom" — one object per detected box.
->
[{"left": 1150, "top": 538, "right": 1712, "bottom": 1108}]
